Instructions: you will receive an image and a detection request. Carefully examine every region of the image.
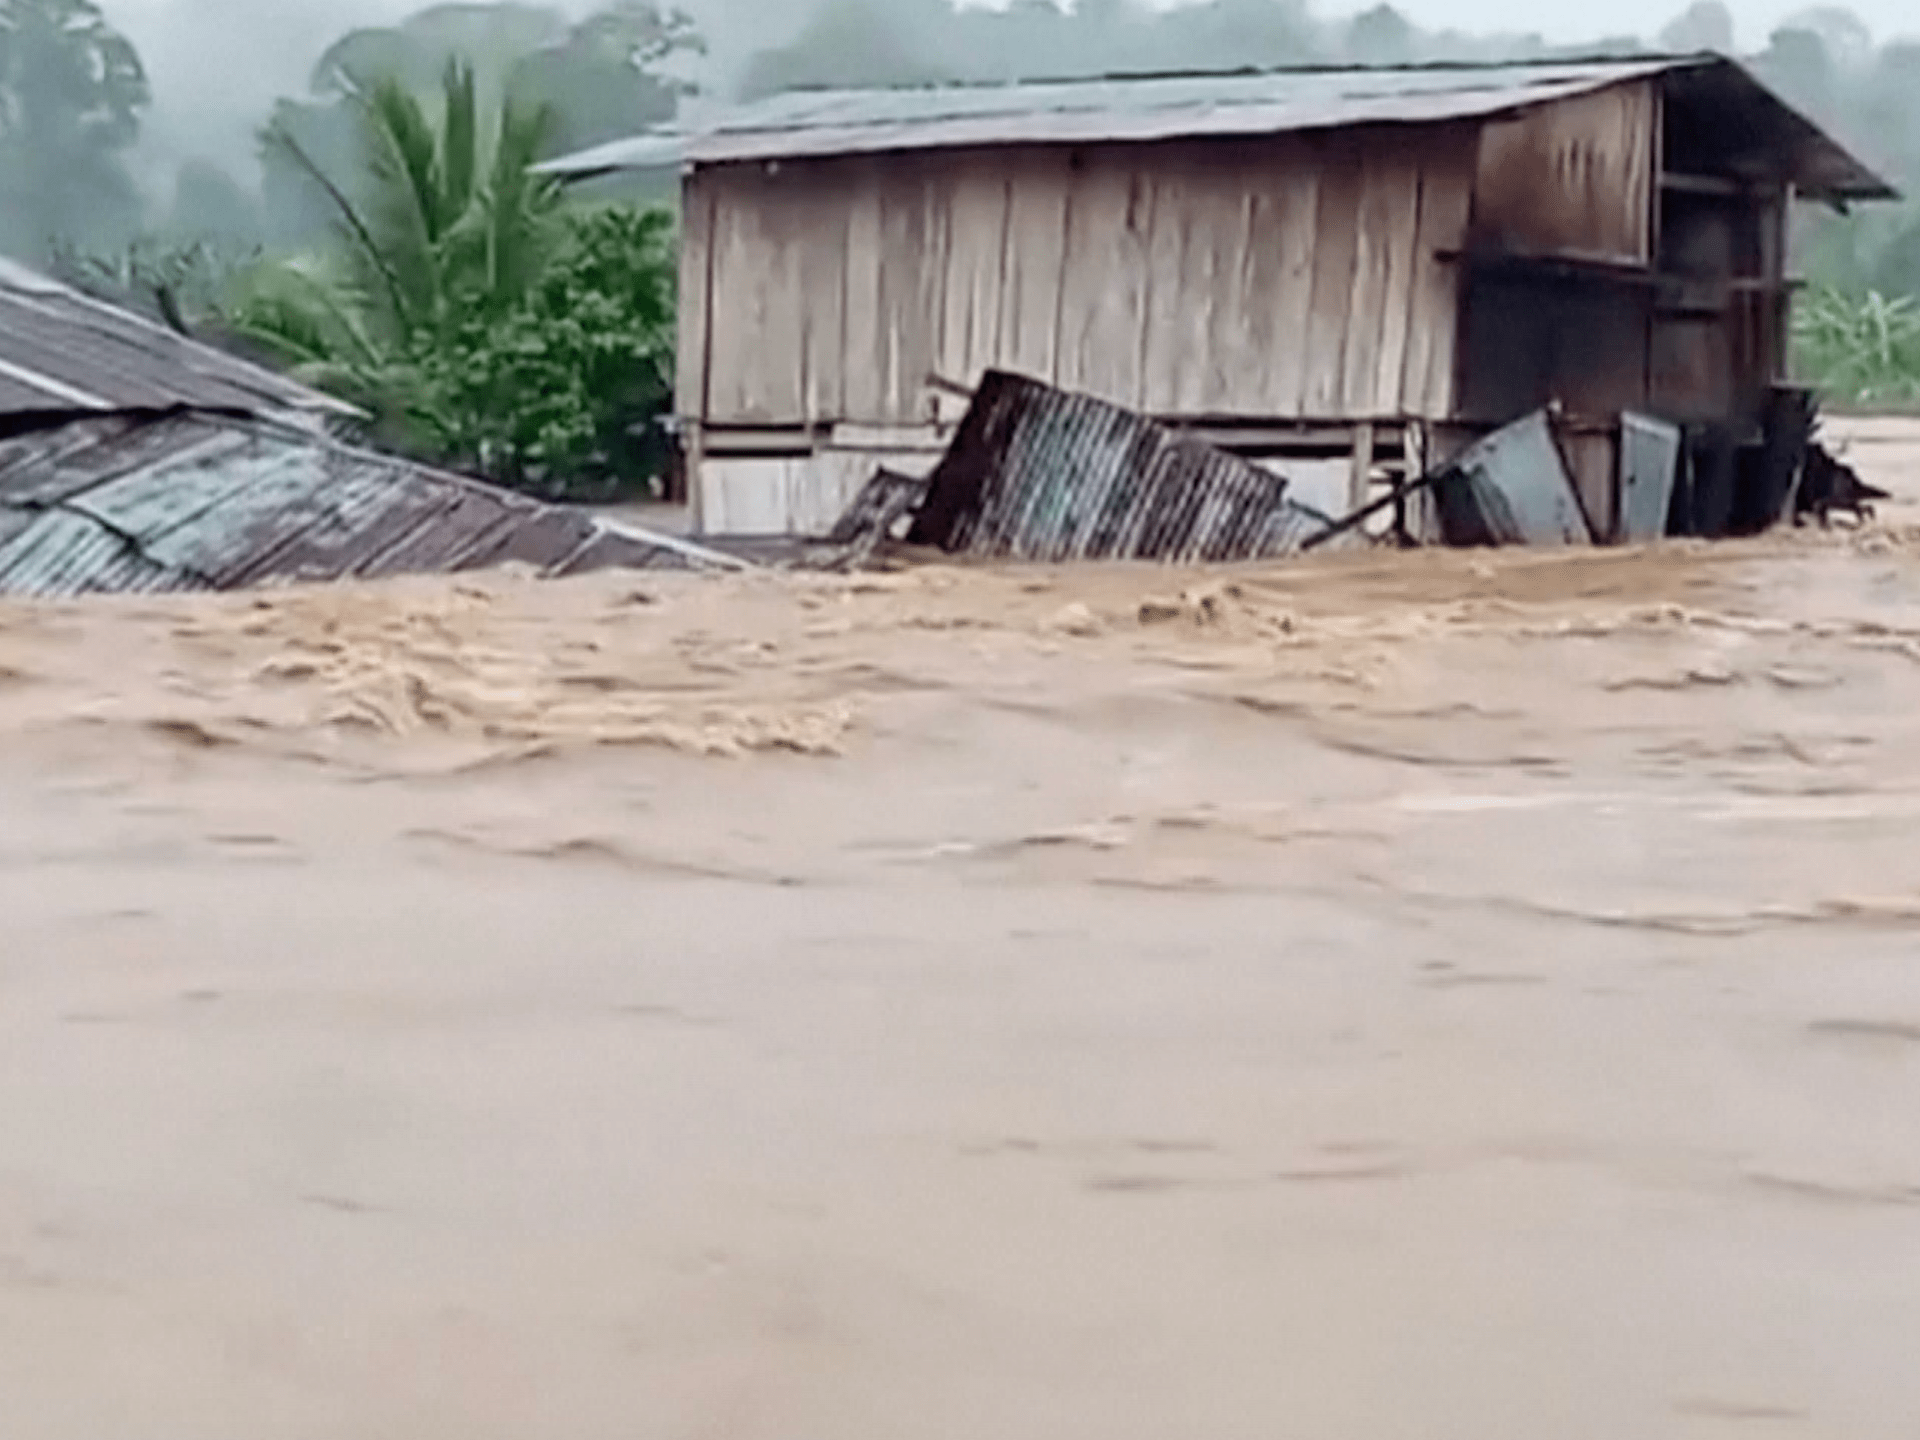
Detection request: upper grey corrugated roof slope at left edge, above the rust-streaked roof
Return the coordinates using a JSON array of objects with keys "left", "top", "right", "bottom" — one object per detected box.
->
[{"left": 0, "top": 259, "right": 355, "bottom": 417}]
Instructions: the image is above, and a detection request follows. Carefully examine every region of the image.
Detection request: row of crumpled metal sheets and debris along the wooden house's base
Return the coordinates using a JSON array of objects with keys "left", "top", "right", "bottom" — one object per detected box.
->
[{"left": 804, "top": 371, "right": 1880, "bottom": 568}]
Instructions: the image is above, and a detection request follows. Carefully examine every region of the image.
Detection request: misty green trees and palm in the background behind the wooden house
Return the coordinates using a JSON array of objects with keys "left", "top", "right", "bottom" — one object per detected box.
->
[{"left": 0, "top": 0, "right": 1920, "bottom": 492}]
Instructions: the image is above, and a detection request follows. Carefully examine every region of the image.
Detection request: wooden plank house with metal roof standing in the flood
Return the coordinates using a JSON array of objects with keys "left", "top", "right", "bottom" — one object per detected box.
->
[{"left": 555, "top": 56, "right": 1893, "bottom": 534}]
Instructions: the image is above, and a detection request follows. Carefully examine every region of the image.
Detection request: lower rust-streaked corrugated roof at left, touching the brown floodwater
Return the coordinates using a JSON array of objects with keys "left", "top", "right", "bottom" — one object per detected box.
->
[{"left": 0, "top": 411, "right": 733, "bottom": 595}]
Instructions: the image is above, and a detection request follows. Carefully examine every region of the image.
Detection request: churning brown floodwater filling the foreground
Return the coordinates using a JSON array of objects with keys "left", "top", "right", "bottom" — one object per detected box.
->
[{"left": 0, "top": 426, "right": 1920, "bottom": 1440}]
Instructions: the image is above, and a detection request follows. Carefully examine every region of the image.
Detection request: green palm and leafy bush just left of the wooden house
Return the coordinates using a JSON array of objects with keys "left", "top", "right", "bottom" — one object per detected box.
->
[{"left": 225, "top": 61, "right": 674, "bottom": 495}]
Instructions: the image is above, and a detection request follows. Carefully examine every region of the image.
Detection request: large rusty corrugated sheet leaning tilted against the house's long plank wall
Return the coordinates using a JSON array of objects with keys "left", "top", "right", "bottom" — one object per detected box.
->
[{"left": 910, "top": 371, "right": 1321, "bottom": 563}]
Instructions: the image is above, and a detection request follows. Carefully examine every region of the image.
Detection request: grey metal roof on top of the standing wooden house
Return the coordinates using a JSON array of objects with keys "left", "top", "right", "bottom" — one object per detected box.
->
[{"left": 543, "top": 56, "right": 1893, "bottom": 200}]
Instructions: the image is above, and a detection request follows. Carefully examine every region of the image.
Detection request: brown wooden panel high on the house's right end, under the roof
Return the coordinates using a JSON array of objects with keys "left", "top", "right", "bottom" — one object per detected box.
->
[{"left": 1473, "top": 81, "right": 1659, "bottom": 265}]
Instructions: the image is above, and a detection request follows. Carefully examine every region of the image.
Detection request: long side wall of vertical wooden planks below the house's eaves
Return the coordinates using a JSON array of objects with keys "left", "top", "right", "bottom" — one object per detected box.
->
[{"left": 680, "top": 125, "right": 1480, "bottom": 426}]
